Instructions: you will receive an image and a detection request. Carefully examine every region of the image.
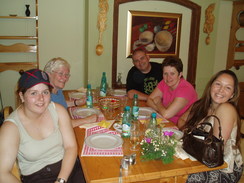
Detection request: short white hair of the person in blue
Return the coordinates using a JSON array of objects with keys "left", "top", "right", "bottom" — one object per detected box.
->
[{"left": 44, "top": 57, "right": 70, "bottom": 73}]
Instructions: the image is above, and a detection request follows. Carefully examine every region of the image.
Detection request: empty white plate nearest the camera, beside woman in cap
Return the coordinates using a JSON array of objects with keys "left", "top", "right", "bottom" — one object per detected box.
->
[{"left": 85, "top": 133, "right": 123, "bottom": 149}]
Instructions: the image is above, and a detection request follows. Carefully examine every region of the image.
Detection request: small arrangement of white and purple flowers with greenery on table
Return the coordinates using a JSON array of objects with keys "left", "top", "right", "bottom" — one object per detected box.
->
[{"left": 140, "top": 129, "right": 178, "bottom": 164}]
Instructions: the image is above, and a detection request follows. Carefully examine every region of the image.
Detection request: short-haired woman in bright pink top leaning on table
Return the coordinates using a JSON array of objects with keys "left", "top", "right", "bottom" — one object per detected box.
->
[{"left": 147, "top": 56, "right": 197, "bottom": 125}]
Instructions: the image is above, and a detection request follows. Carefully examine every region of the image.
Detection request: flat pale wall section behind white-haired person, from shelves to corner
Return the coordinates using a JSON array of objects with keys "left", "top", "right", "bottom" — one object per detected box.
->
[{"left": 39, "top": 0, "right": 87, "bottom": 88}]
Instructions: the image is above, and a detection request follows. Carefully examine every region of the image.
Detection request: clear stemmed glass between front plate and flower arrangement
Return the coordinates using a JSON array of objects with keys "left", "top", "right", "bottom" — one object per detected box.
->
[{"left": 130, "top": 121, "right": 141, "bottom": 151}]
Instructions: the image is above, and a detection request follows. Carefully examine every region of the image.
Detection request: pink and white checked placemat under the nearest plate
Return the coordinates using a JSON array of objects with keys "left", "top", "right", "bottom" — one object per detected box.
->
[{"left": 81, "top": 126, "right": 123, "bottom": 156}]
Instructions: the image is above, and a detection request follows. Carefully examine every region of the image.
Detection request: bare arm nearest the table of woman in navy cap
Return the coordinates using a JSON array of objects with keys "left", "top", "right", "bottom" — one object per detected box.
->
[{"left": 55, "top": 104, "right": 77, "bottom": 181}]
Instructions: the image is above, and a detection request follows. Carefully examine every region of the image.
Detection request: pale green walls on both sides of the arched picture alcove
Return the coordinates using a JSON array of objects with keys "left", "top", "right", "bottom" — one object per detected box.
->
[{"left": 0, "top": 0, "right": 244, "bottom": 106}]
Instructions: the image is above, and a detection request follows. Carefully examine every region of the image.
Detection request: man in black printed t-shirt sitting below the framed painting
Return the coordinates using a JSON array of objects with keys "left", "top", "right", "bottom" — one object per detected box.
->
[{"left": 126, "top": 49, "right": 163, "bottom": 100}]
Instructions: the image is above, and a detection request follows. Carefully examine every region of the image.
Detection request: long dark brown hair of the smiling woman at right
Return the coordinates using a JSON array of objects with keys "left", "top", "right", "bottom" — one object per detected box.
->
[{"left": 183, "top": 70, "right": 241, "bottom": 144}]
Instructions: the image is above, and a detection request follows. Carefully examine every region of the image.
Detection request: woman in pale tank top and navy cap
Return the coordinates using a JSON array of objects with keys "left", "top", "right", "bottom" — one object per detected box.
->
[{"left": 0, "top": 69, "right": 83, "bottom": 183}]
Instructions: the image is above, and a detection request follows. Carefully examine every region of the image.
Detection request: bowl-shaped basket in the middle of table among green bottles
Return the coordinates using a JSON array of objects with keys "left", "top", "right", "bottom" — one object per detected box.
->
[{"left": 98, "top": 97, "right": 120, "bottom": 120}]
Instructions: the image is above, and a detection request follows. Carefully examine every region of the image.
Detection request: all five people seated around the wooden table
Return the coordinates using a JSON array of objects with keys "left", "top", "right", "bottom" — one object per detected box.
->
[{"left": 0, "top": 49, "right": 243, "bottom": 183}]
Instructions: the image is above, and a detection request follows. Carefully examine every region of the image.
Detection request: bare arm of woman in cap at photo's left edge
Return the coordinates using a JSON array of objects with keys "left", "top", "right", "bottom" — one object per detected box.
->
[{"left": 0, "top": 122, "right": 19, "bottom": 183}]
